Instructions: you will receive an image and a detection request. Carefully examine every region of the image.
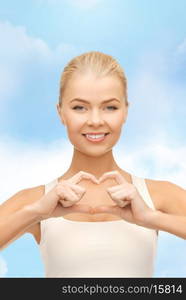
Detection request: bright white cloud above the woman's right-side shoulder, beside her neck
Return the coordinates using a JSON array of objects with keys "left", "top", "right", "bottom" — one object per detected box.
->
[{"left": 116, "top": 134, "right": 186, "bottom": 188}]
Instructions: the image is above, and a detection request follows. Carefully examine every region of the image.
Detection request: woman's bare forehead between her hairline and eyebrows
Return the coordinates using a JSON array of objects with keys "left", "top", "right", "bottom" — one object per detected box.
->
[{"left": 64, "top": 74, "right": 123, "bottom": 100}]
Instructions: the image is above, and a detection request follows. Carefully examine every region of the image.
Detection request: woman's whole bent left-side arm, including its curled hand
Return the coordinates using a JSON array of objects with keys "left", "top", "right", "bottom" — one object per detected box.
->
[{"left": 0, "top": 171, "right": 97, "bottom": 249}]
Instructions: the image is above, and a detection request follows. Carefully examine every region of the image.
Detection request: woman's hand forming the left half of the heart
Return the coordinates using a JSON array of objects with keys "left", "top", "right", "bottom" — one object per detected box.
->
[{"left": 32, "top": 171, "right": 98, "bottom": 220}]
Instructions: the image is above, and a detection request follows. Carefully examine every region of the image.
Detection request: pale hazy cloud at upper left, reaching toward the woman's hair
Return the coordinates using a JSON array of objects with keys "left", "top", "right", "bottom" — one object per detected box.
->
[{"left": 0, "top": 22, "right": 76, "bottom": 105}]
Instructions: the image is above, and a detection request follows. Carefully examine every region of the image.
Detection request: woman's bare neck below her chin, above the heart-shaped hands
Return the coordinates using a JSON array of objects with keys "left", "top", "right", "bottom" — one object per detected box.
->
[{"left": 66, "top": 149, "right": 121, "bottom": 178}]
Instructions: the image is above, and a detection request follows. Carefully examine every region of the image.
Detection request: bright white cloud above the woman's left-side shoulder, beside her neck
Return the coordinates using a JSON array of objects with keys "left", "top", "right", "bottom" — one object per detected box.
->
[{"left": 0, "top": 137, "right": 72, "bottom": 203}]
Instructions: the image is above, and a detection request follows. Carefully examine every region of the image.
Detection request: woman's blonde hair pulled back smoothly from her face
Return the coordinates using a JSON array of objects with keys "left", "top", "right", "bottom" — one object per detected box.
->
[{"left": 59, "top": 51, "right": 128, "bottom": 106}]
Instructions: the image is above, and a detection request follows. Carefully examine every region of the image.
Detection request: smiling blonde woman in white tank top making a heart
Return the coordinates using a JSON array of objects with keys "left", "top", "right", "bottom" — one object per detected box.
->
[{"left": 0, "top": 51, "right": 186, "bottom": 277}]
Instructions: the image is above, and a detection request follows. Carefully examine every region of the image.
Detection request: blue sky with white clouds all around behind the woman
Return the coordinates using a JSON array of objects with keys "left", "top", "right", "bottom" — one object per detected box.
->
[{"left": 0, "top": 0, "right": 186, "bottom": 277}]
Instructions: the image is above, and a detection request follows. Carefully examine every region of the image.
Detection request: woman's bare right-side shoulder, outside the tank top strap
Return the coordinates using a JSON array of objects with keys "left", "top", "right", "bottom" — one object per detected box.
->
[{"left": 145, "top": 178, "right": 186, "bottom": 215}]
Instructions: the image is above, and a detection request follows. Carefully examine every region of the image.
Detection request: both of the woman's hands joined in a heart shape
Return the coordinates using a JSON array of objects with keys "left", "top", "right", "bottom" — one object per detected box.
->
[{"left": 54, "top": 171, "right": 154, "bottom": 227}]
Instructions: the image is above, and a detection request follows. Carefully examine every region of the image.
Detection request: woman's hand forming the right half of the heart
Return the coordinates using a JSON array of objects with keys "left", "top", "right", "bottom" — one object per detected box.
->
[{"left": 94, "top": 171, "right": 154, "bottom": 227}]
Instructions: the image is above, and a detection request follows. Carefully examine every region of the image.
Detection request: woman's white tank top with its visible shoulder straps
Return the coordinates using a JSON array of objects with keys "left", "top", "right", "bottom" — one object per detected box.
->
[{"left": 39, "top": 175, "right": 158, "bottom": 278}]
